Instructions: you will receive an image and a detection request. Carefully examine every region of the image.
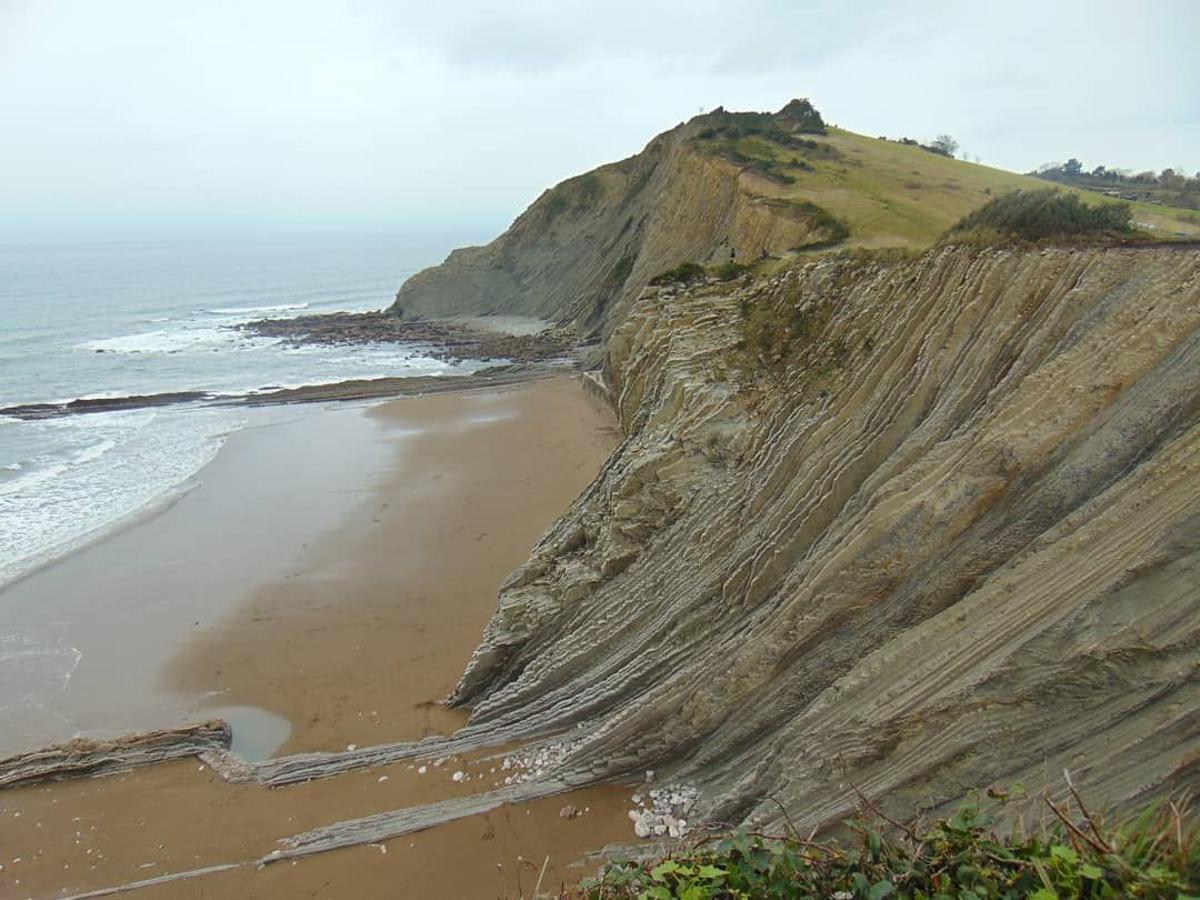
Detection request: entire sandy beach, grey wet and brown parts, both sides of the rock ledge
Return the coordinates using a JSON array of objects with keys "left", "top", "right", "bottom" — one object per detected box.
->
[{"left": 0, "top": 378, "right": 629, "bottom": 898}]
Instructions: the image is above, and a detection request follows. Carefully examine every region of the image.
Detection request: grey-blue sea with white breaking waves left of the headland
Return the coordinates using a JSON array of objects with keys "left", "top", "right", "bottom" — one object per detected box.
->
[{"left": 0, "top": 238, "right": 475, "bottom": 592}]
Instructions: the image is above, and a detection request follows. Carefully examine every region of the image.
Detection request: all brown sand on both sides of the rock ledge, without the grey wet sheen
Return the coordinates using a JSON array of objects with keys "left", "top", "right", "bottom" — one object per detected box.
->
[{"left": 0, "top": 378, "right": 629, "bottom": 898}]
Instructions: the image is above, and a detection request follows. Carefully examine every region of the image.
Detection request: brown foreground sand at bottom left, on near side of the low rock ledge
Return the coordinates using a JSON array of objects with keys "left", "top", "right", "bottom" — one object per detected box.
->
[{"left": 0, "top": 761, "right": 630, "bottom": 900}]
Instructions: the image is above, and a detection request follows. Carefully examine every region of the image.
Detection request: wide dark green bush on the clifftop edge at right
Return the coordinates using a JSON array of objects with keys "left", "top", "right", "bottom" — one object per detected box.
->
[{"left": 949, "top": 188, "right": 1133, "bottom": 240}]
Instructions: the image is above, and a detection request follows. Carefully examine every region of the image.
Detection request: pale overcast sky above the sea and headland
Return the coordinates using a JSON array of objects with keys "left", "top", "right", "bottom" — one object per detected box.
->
[{"left": 0, "top": 0, "right": 1200, "bottom": 241}]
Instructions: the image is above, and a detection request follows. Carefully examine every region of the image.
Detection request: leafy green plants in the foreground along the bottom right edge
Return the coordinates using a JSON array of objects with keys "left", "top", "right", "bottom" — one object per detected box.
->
[{"left": 574, "top": 790, "right": 1200, "bottom": 900}]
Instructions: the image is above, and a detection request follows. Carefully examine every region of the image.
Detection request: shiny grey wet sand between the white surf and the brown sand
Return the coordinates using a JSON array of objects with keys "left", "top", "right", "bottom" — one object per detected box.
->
[{"left": 0, "top": 406, "right": 403, "bottom": 754}]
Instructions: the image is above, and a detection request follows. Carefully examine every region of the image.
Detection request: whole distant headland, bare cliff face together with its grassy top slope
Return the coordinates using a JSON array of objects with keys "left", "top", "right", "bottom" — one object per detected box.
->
[{"left": 391, "top": 101, "right": 1056, "bottom": 336}]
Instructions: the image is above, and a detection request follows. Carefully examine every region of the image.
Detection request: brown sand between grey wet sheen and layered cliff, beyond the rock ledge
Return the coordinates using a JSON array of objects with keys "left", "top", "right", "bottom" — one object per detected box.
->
[{"left": 169, "top": 378, "right": 617, "bottom": 752}]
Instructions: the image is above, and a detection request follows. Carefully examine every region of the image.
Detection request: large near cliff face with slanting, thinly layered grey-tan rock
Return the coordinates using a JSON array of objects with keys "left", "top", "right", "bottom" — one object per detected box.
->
[{"left": 455, "top": 243, "right": 1200, "bottom": 827}]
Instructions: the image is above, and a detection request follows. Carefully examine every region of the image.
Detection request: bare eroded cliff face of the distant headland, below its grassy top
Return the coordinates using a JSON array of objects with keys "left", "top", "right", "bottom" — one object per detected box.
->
[{"left": 392, "top": 118, "right": 830, "bottom": 335}]
